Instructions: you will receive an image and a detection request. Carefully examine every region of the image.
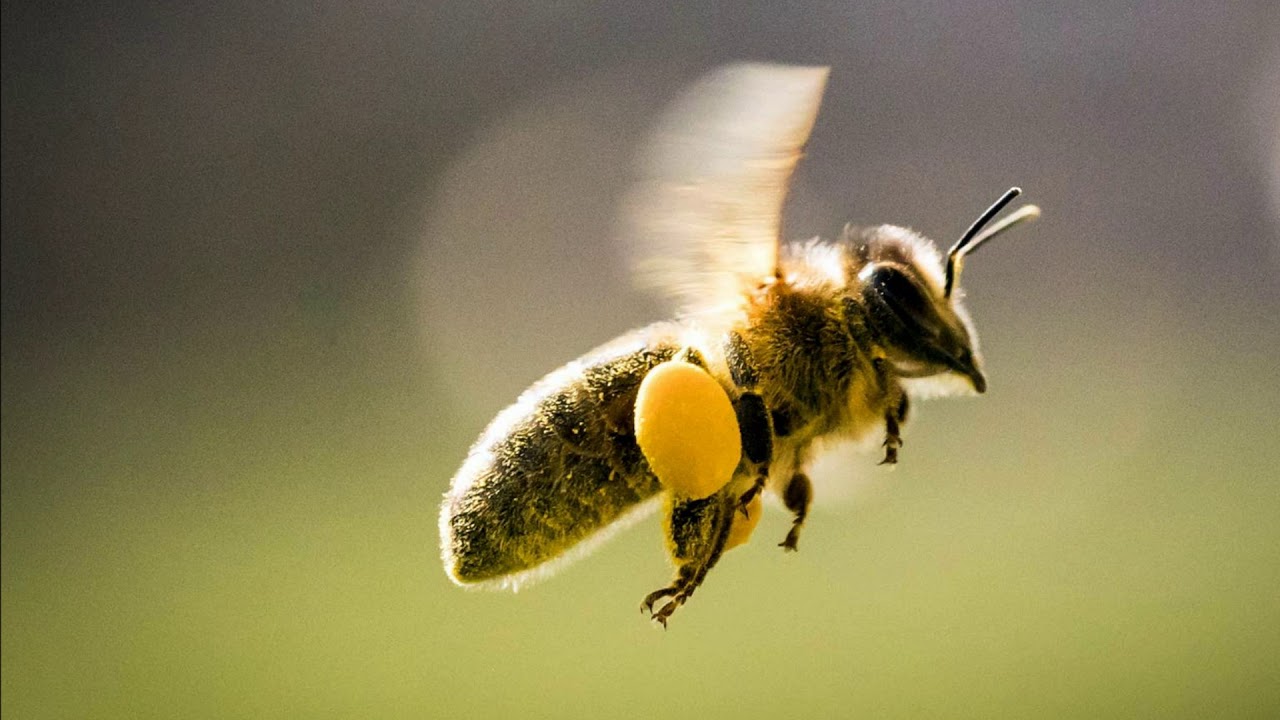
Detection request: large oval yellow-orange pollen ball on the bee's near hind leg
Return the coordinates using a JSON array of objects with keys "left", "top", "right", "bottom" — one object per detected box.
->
[{"left": 635, "top": 361, "right": 742, "bottom": 498}]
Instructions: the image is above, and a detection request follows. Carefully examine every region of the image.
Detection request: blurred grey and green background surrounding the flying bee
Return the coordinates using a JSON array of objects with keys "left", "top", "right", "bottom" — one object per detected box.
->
[{"left": 0, "top": 0, "right": 1280, "bottom": 719}]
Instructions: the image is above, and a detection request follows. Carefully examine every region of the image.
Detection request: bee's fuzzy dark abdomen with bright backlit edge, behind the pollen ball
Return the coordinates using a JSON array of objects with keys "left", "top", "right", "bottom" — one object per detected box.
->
[{"left": 440, "top": 333, "right": 677, "bottom": 584}]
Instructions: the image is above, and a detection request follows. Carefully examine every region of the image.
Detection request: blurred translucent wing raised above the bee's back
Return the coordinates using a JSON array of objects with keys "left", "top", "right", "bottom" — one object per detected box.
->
[{"left": 625, "top": 64, "right": 828, "bottom": 311}]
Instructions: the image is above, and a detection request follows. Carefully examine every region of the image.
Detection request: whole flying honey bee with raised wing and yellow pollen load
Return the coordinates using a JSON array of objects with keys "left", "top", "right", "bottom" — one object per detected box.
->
[{"left": 440, "top": 64, "right": 1039, "bottom": 626}]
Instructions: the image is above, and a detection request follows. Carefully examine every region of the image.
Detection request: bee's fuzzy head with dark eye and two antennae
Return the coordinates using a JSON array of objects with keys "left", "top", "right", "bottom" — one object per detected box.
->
[{"left": 854, "top": 188, "right": 1039, "bottom": 392}]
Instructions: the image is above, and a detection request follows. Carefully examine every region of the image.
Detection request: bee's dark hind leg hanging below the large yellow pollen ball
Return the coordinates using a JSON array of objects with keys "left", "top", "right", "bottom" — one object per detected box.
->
[{"left": 641, "top": 491, "right": 737, "bottom": 628}]
